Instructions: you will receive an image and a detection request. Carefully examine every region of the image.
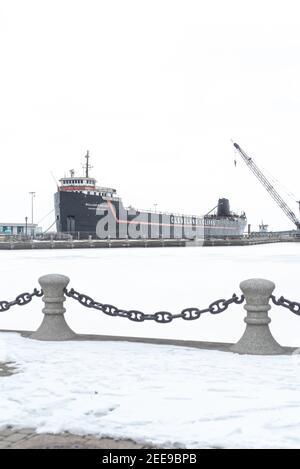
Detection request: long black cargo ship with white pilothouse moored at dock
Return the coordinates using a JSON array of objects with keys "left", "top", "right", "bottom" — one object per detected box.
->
[{"left": 54, "top": 152, "right": 247, "bottom": 240}]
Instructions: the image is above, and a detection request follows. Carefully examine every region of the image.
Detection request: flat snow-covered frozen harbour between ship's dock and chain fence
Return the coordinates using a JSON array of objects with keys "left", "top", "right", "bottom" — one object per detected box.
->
[{"left": 0, "top": 243, "right": 300, "bottom": 347}]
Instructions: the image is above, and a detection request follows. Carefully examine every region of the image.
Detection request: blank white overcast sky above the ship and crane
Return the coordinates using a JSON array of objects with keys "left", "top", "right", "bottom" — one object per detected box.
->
[{"left": 0, "top": 0, "right": 300, "bottom": 229}]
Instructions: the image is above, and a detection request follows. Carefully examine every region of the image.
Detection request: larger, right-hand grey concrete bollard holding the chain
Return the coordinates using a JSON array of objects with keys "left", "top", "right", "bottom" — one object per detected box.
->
[{"left": 230, "top": 278, "right": 286, "bottom": 355}]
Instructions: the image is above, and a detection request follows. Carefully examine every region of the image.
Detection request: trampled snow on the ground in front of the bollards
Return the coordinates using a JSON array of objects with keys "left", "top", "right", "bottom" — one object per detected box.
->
[{"left": 0, "top": 333, "right": 300, "bottom": 448}]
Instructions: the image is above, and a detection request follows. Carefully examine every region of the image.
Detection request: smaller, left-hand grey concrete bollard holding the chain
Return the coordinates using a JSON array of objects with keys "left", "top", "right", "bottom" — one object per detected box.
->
[{"left": 30, "top": 274, "right": 76, "bottom": 340}]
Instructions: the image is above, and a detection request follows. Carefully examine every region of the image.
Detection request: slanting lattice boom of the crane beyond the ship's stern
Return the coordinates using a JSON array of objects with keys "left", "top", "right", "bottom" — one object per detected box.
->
[{"left": 233, "top": 143, "right": 300, "bottom": 230}]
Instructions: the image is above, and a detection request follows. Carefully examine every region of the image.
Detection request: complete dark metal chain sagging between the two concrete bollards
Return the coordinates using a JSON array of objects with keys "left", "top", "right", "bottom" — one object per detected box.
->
[{"left": 64, "top": 288, "right": 244, "bottom": 324}]
